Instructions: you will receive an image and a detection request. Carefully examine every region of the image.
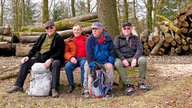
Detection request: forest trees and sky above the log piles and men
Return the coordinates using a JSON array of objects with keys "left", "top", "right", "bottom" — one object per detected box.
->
[{"left": 0, "top": 0, "right": 191, "bottom": 36}]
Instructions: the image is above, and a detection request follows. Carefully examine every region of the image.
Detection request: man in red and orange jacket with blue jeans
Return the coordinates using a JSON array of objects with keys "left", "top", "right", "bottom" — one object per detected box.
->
[{"left": 64, "top": 24, "right": 87, "bottom": 93}]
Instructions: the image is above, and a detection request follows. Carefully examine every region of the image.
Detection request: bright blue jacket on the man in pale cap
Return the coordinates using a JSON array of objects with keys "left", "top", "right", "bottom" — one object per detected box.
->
[{"left": 86, "top": 30, "right": 115, "bottom": 68}]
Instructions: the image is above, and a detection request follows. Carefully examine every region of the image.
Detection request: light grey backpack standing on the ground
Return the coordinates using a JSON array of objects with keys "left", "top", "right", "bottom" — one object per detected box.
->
[{"left": 26, "top": 63, "right": 51, "bottom": 96}]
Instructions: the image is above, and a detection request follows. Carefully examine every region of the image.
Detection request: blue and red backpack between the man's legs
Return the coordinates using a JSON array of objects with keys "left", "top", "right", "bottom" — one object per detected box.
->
[{"left": 88, "top": 70, "right": 112, "bottom": 98}]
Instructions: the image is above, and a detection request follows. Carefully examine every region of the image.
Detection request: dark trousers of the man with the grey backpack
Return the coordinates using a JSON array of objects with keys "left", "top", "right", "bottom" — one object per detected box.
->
[{"left": 15, "top": 59, "right": 61, "bottom": 90}]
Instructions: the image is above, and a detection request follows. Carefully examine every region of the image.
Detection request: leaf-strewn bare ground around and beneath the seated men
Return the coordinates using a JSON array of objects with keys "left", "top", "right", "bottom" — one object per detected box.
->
[{"left": 0, "top": 56, "right": 192, "bottom": 108}]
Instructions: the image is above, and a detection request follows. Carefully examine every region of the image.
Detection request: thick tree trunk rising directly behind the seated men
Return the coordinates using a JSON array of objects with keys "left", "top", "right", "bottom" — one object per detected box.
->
[{"left": 97, "top": 0, "right": 119, "bottom": 37}]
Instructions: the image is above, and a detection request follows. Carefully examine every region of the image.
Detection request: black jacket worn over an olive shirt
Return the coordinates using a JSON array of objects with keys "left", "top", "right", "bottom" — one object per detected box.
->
[{"left": 27, "top": 33, "right": 64, "bottom": 64}]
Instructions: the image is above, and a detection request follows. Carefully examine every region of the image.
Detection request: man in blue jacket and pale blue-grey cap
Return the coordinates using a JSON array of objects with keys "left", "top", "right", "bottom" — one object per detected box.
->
[{"left": 84, "top": 22, "right": 115, "bottom": 97}]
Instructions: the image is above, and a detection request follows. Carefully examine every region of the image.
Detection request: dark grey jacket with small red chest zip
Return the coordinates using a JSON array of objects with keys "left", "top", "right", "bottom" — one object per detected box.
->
[{"left": 114, "top": 34, "right": 143, "bottom": 60}]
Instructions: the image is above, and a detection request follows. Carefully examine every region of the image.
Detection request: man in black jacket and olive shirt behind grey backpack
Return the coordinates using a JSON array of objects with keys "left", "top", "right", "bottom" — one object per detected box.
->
[{"left": 7, "top": 21, "right": 64, "bottom": 98}]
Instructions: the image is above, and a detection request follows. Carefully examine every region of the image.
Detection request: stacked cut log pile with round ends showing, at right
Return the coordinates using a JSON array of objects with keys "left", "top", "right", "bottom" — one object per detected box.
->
[{"left": 140, "top": 3, "right": 192, "bottom": 55}]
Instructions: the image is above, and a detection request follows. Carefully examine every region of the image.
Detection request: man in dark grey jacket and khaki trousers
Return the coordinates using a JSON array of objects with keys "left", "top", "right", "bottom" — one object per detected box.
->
[{"left": 114, "top": 22, "right": 149, "bottom": 95}]
